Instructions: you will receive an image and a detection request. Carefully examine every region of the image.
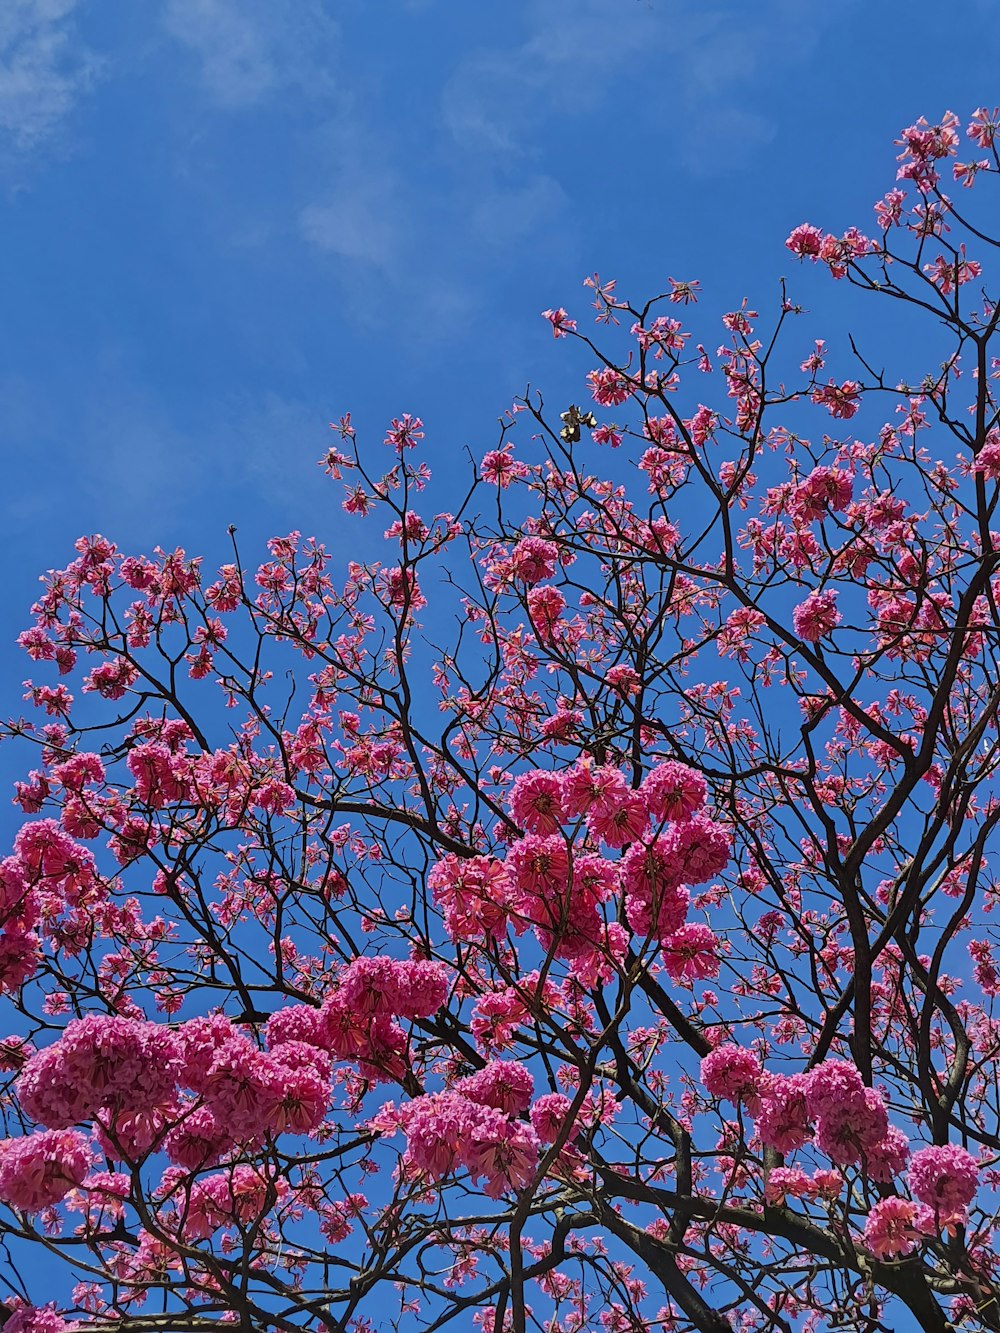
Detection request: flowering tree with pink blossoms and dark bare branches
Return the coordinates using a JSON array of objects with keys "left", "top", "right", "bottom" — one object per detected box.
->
[{"left": 0, "top": 109, "right": 1000, "bottom": 1333}]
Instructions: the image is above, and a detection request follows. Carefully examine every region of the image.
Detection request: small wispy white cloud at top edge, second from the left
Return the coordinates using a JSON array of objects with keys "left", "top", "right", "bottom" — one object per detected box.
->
[{"left": 164, "top": 0, "right": 339, "bottom": 111}]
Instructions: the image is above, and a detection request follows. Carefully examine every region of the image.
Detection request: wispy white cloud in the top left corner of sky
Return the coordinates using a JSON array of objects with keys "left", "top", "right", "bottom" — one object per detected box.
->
[{"left": 0, "top": 0, "right": 101, "bottom": 155}]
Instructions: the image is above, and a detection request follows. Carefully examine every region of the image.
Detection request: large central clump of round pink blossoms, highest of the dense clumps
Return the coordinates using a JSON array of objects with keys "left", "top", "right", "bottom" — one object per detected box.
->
[{"left": 429, "top": 757, "right": 729, "bottom": 981}]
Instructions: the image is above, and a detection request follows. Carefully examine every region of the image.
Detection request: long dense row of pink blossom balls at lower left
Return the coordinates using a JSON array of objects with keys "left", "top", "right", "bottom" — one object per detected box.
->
[{"left": 5, "top": 957, "right": 448, "bottom": 1169}]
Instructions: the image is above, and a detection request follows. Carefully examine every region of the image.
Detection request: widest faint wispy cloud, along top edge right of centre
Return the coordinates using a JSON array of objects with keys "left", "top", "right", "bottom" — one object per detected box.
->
[{"left": 441, "top": 0, "right": 832, "bottom": 172}]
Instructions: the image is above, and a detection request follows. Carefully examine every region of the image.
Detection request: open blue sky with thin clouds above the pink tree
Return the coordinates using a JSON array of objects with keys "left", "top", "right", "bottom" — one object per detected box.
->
[{"left": 0, "top": 0, "right": 1000, "bottom": 730}]
